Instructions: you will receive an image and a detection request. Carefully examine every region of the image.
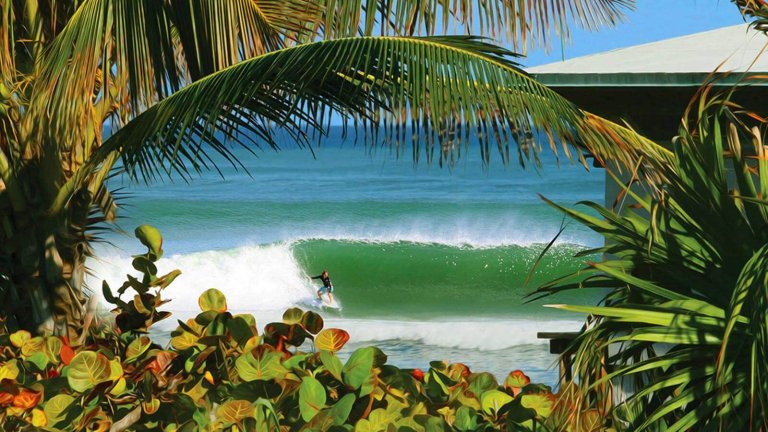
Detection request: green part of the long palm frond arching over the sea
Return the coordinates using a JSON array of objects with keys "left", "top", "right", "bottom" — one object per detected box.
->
[{"left": 52, "top": 36, "right": 608, "bottom": 213}]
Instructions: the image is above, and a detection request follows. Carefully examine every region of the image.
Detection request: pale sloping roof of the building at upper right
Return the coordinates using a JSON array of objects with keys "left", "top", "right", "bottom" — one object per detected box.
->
[{"left": 528, "top": 24, "right": 768, "bottom": 87}]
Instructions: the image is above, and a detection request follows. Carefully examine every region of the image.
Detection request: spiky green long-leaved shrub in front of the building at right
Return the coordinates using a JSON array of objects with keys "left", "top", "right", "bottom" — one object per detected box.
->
[{"left": 538, "top": 78, "right": 768, "bottom": 431}]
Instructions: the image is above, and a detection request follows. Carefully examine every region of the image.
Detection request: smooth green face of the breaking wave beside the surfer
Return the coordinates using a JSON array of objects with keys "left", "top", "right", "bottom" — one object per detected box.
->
[{"left": 293, "top": 240, "right": 599, "bottom": 318}]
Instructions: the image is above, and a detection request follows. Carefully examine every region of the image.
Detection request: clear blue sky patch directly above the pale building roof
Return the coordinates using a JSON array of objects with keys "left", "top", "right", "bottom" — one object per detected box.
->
[{"left": 520, "top": 0, "right": 744, "bottom": 66}]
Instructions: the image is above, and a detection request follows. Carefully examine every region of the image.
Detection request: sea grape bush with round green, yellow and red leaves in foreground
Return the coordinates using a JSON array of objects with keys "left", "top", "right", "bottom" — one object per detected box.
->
[{"left": 0, "top": 225, "right": 556, "bottom": 431}]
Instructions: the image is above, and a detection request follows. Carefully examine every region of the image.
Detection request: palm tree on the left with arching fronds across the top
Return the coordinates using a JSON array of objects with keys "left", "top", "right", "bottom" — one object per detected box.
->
[{"left": 0, "top": 0, "right": 648, "bottom": 336}]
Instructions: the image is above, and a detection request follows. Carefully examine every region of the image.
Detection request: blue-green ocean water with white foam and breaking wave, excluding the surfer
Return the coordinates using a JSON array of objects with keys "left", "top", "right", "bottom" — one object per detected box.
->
[{"left": 89, "top": 133, "right": 604, "bottom": 385}]
